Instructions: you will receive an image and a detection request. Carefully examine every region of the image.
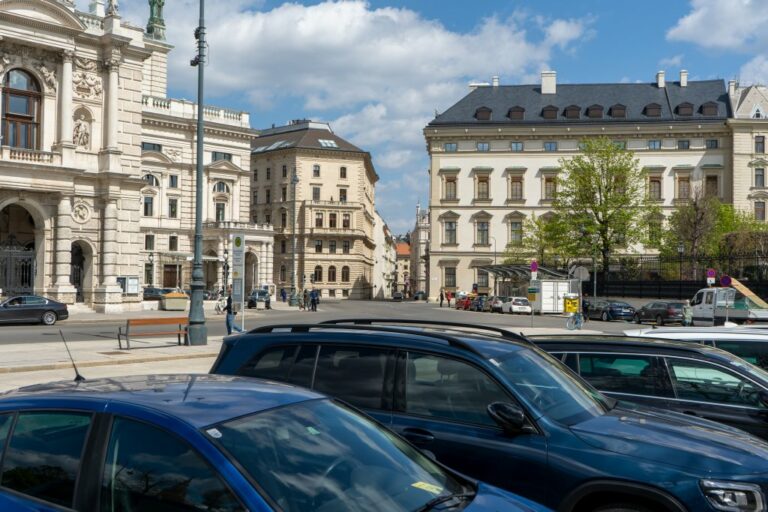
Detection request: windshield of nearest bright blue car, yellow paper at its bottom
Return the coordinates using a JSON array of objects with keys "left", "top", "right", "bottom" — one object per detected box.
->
[{"left": 206, "top": 400, "right": 474, "bottom": 512}]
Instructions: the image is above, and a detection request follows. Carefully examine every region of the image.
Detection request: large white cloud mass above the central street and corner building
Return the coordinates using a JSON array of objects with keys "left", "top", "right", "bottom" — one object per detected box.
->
[{"left": 78, "top": 0, "right": 593, "bottom": 232}]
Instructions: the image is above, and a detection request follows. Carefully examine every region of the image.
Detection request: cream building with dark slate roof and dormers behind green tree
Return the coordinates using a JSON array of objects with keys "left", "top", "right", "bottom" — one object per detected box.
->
[{"left": 424, "top": 72, "right": 734, "bottom": 297}]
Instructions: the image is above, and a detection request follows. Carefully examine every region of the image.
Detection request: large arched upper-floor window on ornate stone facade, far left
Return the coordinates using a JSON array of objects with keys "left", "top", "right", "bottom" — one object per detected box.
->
[{"left": 2, "top": 69, "right": 41, "bottom": 149}]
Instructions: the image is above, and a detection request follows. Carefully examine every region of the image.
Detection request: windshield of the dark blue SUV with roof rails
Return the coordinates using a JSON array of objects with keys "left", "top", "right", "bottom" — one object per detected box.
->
[{"left": 491, "top": 350, "right": 612, "bottom": 425}]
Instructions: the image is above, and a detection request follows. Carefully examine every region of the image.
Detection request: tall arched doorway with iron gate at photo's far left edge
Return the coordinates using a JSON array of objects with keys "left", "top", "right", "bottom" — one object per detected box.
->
[{"left": 0, "top": 204, "right": 36, "bottom": 295}]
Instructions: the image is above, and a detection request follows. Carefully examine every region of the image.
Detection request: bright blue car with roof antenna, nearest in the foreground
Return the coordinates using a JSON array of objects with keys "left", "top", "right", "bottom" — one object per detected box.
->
[{"left": 0, "top": 375, "right": 546, "bottom": 512}]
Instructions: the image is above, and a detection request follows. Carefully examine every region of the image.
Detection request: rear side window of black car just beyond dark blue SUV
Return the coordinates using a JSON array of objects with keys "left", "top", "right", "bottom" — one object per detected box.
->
[{"left": 579, "top": 354, "right": 672, "bottom": 397}]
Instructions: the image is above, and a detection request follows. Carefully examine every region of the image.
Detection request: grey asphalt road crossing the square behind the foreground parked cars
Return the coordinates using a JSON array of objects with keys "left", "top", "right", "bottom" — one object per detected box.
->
[{"left": 0, "top": 301, "right": 634, "bottom": 346}]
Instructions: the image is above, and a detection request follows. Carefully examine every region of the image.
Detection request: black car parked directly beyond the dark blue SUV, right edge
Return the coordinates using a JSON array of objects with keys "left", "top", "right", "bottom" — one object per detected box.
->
[{"left": 531, "top": 335, "right": 768, "bottom": 439}]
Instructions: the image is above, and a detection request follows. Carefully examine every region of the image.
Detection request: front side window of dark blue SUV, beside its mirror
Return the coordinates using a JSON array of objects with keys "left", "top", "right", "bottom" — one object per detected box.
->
[{"left": 404, "top": 352, "right": 510, "bottom": 427}]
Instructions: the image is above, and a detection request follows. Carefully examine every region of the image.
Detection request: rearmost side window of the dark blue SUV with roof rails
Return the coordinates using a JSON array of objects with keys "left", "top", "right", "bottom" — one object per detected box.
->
[{"left": 237, "top": 345, "right": 317, "bottom": 387}]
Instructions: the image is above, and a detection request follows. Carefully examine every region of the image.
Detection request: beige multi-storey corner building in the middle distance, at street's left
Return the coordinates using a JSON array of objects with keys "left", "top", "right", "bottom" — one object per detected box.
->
[{"left": 251, "top": 120, "right": 378, "bottom": 299}]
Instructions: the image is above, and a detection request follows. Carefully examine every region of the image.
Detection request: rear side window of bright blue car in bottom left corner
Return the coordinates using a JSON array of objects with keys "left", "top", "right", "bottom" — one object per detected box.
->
[{"left": 0, "top": 412, "right": 91, "bottom": 507}]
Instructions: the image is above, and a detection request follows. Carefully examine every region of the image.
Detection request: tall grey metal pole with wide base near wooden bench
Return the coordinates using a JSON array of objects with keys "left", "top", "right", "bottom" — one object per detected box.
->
[{"left": 187, "top": 0, "right": 208, "bottom": 345}]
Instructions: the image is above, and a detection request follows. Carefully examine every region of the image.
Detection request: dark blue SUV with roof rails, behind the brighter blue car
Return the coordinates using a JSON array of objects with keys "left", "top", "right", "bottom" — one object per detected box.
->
[{"left": 212, "top": 320, "right": 768, "bottom": 512}]
